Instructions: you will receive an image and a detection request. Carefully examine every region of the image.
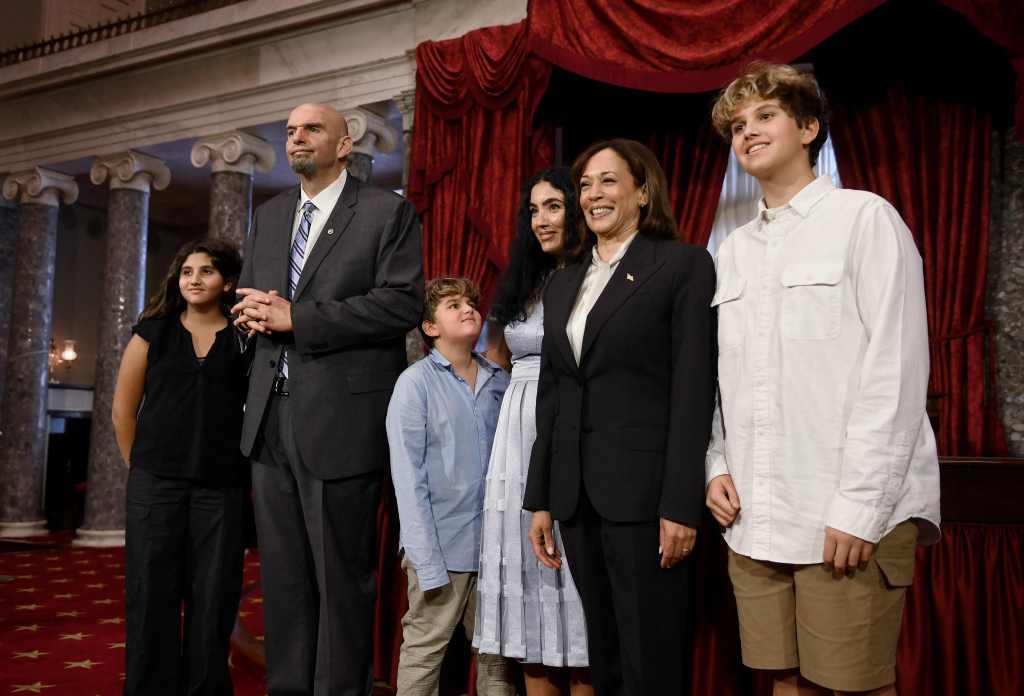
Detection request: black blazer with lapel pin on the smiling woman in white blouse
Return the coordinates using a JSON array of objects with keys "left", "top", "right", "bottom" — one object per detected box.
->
[{"left": 523, "top": 234, "right": 717, "bottom": 526}]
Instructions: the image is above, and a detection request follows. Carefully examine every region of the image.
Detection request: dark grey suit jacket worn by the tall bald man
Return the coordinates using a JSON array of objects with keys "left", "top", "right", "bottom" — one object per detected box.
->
[{"left": 239, "top": 174, "right": 423, "bottom": 479}]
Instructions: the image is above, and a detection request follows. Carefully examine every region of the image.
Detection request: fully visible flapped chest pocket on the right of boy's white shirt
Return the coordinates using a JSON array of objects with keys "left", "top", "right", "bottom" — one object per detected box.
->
[{"left": 781, "top": 260, "right": 843, "bottom": 340}]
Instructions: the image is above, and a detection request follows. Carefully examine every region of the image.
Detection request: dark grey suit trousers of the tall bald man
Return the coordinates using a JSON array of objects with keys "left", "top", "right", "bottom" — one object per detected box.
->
[{"left": 253, "top": 396, "right": 381, "bottom": 696}]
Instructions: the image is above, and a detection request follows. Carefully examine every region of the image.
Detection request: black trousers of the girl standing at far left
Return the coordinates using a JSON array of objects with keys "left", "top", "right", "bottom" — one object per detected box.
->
[{"left": 124, "top": 468, "right": 248, "bottom": 696}]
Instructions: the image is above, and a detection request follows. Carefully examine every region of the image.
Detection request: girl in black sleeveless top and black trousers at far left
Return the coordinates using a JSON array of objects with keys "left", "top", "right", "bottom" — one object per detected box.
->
[{"left": 112, "top": 240, "right": 249, "bottom": 696}]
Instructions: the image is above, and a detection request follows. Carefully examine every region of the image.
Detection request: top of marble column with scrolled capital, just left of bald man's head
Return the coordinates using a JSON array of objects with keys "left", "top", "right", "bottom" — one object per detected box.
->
[{"left": 191, "top": 131, "right": 275, "bottom": 249}]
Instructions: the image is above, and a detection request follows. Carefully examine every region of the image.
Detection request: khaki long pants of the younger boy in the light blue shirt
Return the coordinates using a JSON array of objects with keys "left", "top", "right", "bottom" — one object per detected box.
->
[{"left": 397, "top": 557, "right": 515, "bottom": 696}]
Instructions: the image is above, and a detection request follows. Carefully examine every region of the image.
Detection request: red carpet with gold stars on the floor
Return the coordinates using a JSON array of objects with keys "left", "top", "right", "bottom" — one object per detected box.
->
[{"left": 0, "top": 542, "right": 264, "bottom": 696}]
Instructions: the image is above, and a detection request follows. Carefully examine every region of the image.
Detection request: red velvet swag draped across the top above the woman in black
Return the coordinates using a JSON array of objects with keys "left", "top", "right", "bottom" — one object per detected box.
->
[{"left": 526, "top": 0, "right": 885, "bottom": 92}]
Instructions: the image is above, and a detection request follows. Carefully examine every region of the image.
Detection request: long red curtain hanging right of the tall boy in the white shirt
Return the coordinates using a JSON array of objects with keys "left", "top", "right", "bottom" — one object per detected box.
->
[{"left": 816, "top": 5, "right": 1012, "bottom": 455}]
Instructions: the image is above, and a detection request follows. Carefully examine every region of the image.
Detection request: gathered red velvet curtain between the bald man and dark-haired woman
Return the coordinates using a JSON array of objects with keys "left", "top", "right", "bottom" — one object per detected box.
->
[{"left": 409, "top": 23, "right": 552, "bottom": 297}]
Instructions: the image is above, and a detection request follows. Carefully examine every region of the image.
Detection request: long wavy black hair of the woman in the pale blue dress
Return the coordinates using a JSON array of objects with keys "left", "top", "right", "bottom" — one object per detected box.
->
[{"left": 490, "top": 167, "right": 580, "bottom": 327}]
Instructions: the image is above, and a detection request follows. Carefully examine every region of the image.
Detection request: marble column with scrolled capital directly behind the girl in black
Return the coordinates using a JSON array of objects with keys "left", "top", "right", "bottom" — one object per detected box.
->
[{"left": 73, "top": 150, "right": 171, "bottom": 547}]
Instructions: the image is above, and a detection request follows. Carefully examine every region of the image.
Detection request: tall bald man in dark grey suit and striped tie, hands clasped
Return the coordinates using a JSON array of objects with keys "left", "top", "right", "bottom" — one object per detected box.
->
[{"left": 234, "top": 103, "right": 423, "bottom": 696}]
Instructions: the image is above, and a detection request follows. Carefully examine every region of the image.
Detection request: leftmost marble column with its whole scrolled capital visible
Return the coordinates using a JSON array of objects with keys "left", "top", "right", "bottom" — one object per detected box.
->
[{"left": 0, "top": 167, "right": 78, "bottom": 536}]
